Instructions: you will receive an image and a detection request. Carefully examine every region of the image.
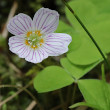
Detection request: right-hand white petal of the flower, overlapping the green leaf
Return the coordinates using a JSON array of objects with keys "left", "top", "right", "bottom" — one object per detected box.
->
[{"left": 43, "top": 33, "right": 72, "bottom": 56}]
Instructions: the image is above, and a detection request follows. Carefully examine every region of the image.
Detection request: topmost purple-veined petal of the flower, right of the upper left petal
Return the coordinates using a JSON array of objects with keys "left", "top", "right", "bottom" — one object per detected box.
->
[{"left": 33, "top": 8, "right": 59, "bottom": 34}]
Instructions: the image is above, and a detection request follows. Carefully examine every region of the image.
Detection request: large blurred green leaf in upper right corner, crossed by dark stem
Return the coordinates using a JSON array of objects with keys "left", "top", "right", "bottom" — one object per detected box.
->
[{"left": 66, "top": 0, "right": 110, "bottom": 54}]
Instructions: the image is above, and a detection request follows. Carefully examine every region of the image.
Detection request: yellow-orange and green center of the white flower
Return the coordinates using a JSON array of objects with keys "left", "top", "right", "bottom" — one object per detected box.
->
[{"left": 25, "top": 31, "right": 44, "bottom": 49}]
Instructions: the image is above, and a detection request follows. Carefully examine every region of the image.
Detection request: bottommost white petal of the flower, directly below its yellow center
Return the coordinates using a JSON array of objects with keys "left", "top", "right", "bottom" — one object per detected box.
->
[{"left": 25, "top": 49, "right": 48, "bottom": 63}]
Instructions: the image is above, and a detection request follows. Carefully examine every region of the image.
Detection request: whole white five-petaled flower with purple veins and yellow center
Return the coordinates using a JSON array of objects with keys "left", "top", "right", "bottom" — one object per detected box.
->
[{"left": 7, "top": 8, "right": 72, "bottom": 63}]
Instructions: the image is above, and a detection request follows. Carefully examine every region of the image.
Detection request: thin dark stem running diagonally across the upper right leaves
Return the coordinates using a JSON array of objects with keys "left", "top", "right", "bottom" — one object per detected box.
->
[{"left": 62, "top": 0, "right": 110, "bottom": 69}]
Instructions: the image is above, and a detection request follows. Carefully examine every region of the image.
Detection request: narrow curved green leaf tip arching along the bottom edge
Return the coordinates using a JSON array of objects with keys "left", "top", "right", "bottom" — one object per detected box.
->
[{"left": 69, "top": 102, "right": 100, "bottom": 110}]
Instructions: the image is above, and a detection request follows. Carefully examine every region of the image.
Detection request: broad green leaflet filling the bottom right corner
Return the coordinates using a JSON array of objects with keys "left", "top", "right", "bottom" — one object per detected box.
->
[{"left": 78, "top": 79, "right": 110, "bottom": 110}]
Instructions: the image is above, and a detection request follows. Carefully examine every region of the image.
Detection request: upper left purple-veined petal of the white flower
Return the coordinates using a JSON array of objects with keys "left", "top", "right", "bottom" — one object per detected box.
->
[{"left": 7, "top": 13, "right": 33, "bottom": 35}]
